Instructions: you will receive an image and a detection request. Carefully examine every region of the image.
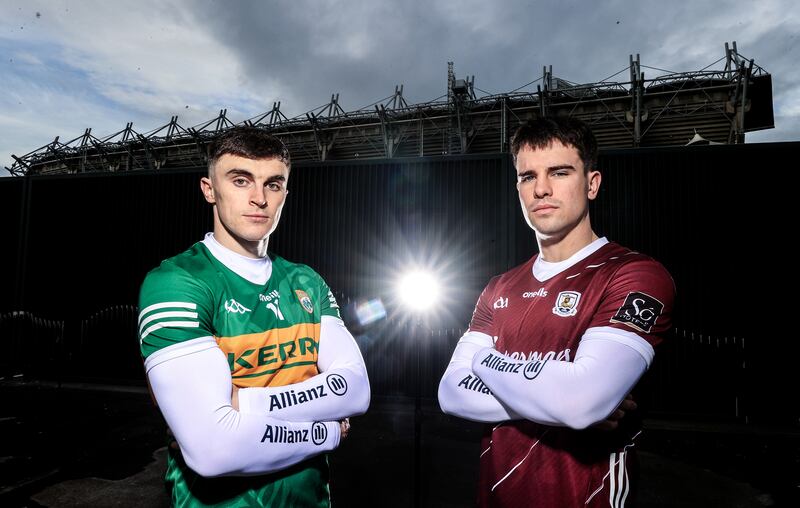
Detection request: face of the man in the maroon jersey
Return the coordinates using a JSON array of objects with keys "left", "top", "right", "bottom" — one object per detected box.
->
[{"left": 516, "top": 140, "right": 600, "bottom": 241}]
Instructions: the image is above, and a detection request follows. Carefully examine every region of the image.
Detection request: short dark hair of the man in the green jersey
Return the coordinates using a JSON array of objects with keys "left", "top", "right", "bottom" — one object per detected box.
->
[{"left": 208, "top": 127, "right": 292, "bottom": 171}]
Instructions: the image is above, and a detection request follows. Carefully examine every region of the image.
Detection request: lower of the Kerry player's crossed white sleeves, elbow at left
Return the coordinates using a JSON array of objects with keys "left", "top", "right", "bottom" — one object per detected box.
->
[{"left": 145, "top": 337, "right": 340, "bottom": 477}]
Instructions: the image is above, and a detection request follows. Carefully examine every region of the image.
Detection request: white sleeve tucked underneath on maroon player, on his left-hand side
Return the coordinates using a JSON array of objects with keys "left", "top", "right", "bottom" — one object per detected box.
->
[{"left": 439, "top": 331, "right": 521, "bottom": 422}]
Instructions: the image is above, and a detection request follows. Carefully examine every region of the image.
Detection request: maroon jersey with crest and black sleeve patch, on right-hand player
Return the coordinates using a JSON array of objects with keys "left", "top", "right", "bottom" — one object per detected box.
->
[{"left": 470, "top": 240, "right": 675, "bottom": 507}]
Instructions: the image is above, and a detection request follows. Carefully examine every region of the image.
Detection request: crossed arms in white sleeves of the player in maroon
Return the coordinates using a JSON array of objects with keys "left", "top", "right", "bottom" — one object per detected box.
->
[{"left": 439, "top": 327, "right": 653, "bottom": 429}]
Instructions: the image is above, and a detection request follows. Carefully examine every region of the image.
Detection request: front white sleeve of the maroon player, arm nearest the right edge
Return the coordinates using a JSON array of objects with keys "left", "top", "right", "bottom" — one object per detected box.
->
[{"left": 472, "top": 327, "right": 653, "bottom": 429}]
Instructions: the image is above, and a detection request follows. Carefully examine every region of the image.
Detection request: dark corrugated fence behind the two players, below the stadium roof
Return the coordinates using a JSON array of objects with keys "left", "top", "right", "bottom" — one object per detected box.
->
[{"left": 0, "top": 143, "right": 788, "bottom": 421}]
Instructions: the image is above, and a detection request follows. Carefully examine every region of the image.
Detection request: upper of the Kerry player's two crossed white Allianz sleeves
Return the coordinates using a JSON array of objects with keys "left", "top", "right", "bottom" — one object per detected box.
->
[{"left": 239, "top": 316, "right": 370, "bottom": 421}]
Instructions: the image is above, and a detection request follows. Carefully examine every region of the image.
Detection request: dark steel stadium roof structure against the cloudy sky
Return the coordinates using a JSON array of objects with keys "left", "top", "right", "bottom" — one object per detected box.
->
[{"left": 6, "top": 41, "right": 774, "bottom": 176}]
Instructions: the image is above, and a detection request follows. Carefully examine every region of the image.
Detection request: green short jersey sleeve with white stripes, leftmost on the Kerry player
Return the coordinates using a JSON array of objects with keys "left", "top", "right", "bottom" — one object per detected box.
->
[{"left": 138, "top": 262, "right": 213, "bottom": 358}]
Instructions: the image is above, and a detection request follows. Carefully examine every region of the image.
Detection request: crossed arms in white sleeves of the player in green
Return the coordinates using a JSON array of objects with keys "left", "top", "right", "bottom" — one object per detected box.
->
[{"left": 145, "top": 316, "right": 370, "bottom": 477}]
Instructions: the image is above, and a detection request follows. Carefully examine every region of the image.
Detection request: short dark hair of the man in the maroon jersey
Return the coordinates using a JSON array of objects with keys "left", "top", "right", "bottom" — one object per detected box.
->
[{"left": 511, "top": 117, "right": 598, "bottom": 171}]
